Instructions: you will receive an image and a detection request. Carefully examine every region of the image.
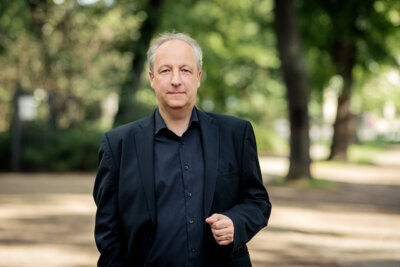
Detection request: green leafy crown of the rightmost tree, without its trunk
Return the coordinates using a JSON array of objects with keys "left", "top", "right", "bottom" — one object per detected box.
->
[{"left": 298, "top": 0, "right": 400, "bottom": 113}]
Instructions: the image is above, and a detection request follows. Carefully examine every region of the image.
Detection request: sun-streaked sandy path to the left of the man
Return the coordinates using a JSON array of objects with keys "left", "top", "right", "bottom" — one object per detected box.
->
[{"left": 0, "top": 174, "right": 98, "bottom": 267}]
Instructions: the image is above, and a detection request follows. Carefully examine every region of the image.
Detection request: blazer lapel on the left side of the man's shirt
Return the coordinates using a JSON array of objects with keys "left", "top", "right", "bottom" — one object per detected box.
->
[{"left": 135, "top": 114, "right": 156, "bottom": 225}]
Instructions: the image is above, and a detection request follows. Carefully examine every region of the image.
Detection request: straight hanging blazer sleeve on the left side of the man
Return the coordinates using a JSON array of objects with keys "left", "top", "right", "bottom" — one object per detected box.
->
[{"left": 93, "top": 134, "right": 124, "bottom": 267}]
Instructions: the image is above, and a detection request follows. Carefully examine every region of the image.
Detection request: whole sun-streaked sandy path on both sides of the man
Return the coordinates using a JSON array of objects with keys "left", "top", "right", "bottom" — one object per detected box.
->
[{"left": 0, "top": 149, "right": 400, "bottom": 267}]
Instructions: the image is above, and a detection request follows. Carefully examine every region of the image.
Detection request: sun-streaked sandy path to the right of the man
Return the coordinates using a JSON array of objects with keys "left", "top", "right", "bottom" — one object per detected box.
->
[{"left": 249, "top": 147, "right": 400, "bottom": 267}]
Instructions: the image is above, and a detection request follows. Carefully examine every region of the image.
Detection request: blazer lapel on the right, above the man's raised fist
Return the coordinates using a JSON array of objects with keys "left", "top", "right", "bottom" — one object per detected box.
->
[{"left": 197, "top": 111, "right": 219, "bottom": 217}]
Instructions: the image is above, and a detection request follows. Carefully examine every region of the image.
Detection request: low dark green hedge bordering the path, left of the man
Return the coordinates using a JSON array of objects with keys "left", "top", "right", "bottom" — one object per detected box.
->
[{"left": 0, "top": 123, "right": 102, "bottom": 172}]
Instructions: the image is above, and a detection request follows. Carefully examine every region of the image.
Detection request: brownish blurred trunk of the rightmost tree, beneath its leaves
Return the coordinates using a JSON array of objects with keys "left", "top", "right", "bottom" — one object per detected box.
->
[{"left": 329, "top": 40, "right": 356, "bottom": 161}]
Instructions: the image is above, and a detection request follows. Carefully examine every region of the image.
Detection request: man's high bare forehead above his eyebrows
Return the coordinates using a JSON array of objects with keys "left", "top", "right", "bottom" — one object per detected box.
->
[{"left": 155, "top": 40, "right": 196, "bottom": 64}]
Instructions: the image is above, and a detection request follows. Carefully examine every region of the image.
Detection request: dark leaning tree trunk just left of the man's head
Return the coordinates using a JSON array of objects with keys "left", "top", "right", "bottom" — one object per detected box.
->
[{"left": 114, "top": 0, "right": 164, "bottom": 126}]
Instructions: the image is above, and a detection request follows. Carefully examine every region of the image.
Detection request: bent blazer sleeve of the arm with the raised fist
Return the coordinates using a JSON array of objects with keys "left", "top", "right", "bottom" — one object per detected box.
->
[{"left": 223, "top": 122, "right": 272, "bottom": 249}]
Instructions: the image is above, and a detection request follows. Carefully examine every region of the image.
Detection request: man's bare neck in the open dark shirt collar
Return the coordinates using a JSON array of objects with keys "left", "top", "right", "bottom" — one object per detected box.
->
[{"left": 158, "top": 106, "right": 193, "bottom": 136}]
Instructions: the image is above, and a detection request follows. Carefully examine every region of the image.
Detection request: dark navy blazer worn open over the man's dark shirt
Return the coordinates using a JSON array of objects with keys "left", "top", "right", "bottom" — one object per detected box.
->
[{"left": 93, "top": 111, "right": 271, "bottom": 267}]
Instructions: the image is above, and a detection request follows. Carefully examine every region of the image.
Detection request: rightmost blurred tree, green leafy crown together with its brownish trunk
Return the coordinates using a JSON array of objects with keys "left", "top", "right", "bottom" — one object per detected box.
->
[{"left": 300, "top": 0, "right": 400, "bottom": 160}]
